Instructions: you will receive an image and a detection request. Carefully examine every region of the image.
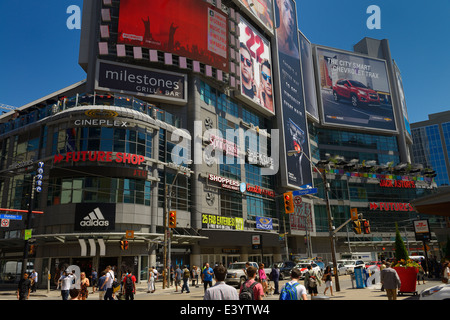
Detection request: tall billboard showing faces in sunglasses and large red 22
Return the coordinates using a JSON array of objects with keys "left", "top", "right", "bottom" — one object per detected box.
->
[{"left": 238, "top": 18, "right": 275, "bottom": 115}]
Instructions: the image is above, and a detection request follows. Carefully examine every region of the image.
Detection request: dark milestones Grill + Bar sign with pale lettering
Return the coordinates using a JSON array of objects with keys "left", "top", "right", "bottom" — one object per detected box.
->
[{"left": 95, "top": 60, "right": 187, "bottom": 104}]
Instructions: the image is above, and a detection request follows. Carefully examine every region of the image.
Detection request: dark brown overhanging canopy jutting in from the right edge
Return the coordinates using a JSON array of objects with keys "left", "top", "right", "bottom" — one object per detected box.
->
[{"left": 410, "top": 187, "right": 450, "bottom": 217}]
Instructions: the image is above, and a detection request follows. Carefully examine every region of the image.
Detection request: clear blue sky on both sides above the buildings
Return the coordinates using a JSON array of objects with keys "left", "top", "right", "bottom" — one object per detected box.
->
[{"left": 0, "top": 0, "right": 450, "bottom": 122}]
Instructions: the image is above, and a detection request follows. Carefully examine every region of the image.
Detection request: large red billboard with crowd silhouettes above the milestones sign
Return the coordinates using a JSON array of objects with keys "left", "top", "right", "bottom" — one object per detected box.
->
[{"left": 117, "top": 0, "right": 229, "bottom": 72}]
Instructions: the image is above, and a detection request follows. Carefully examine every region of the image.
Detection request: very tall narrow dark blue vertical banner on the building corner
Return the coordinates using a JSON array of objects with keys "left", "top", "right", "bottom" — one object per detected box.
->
[{"left": 275, "top": 0, "right": 313, "bottom": 188}]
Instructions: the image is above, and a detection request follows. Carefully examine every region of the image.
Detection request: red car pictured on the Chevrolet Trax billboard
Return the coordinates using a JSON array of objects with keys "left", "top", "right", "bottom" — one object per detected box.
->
[{"left": 333, "top": 79, "right": 380, "bottom": 107}]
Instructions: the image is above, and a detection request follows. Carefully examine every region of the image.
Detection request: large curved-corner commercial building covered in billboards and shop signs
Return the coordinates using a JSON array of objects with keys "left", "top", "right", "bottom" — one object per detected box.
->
[{"left": 0, "top": 0, "right": 443, "bottom": 288}]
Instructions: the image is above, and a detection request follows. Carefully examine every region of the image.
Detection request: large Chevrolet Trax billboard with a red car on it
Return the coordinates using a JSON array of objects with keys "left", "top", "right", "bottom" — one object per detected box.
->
[{"left": 316, "top": 47, "right": 397, "bottom": 131}]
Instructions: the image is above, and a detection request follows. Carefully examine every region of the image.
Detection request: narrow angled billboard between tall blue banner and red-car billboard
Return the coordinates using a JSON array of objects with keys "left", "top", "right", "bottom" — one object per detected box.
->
[{"left": 299, "top": 32, "right": 319, "bottom": 122}]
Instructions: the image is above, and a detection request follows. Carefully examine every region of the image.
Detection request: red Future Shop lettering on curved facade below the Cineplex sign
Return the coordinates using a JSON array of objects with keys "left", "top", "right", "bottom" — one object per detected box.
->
[{"left": 53, "top": 151, "right": 145, "bottom": 165}]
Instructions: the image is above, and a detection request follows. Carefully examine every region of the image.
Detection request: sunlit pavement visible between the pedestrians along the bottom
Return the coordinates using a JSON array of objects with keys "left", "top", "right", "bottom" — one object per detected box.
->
[{"left": 0, "top": 279, "right": 441, "bottom": 301}]
